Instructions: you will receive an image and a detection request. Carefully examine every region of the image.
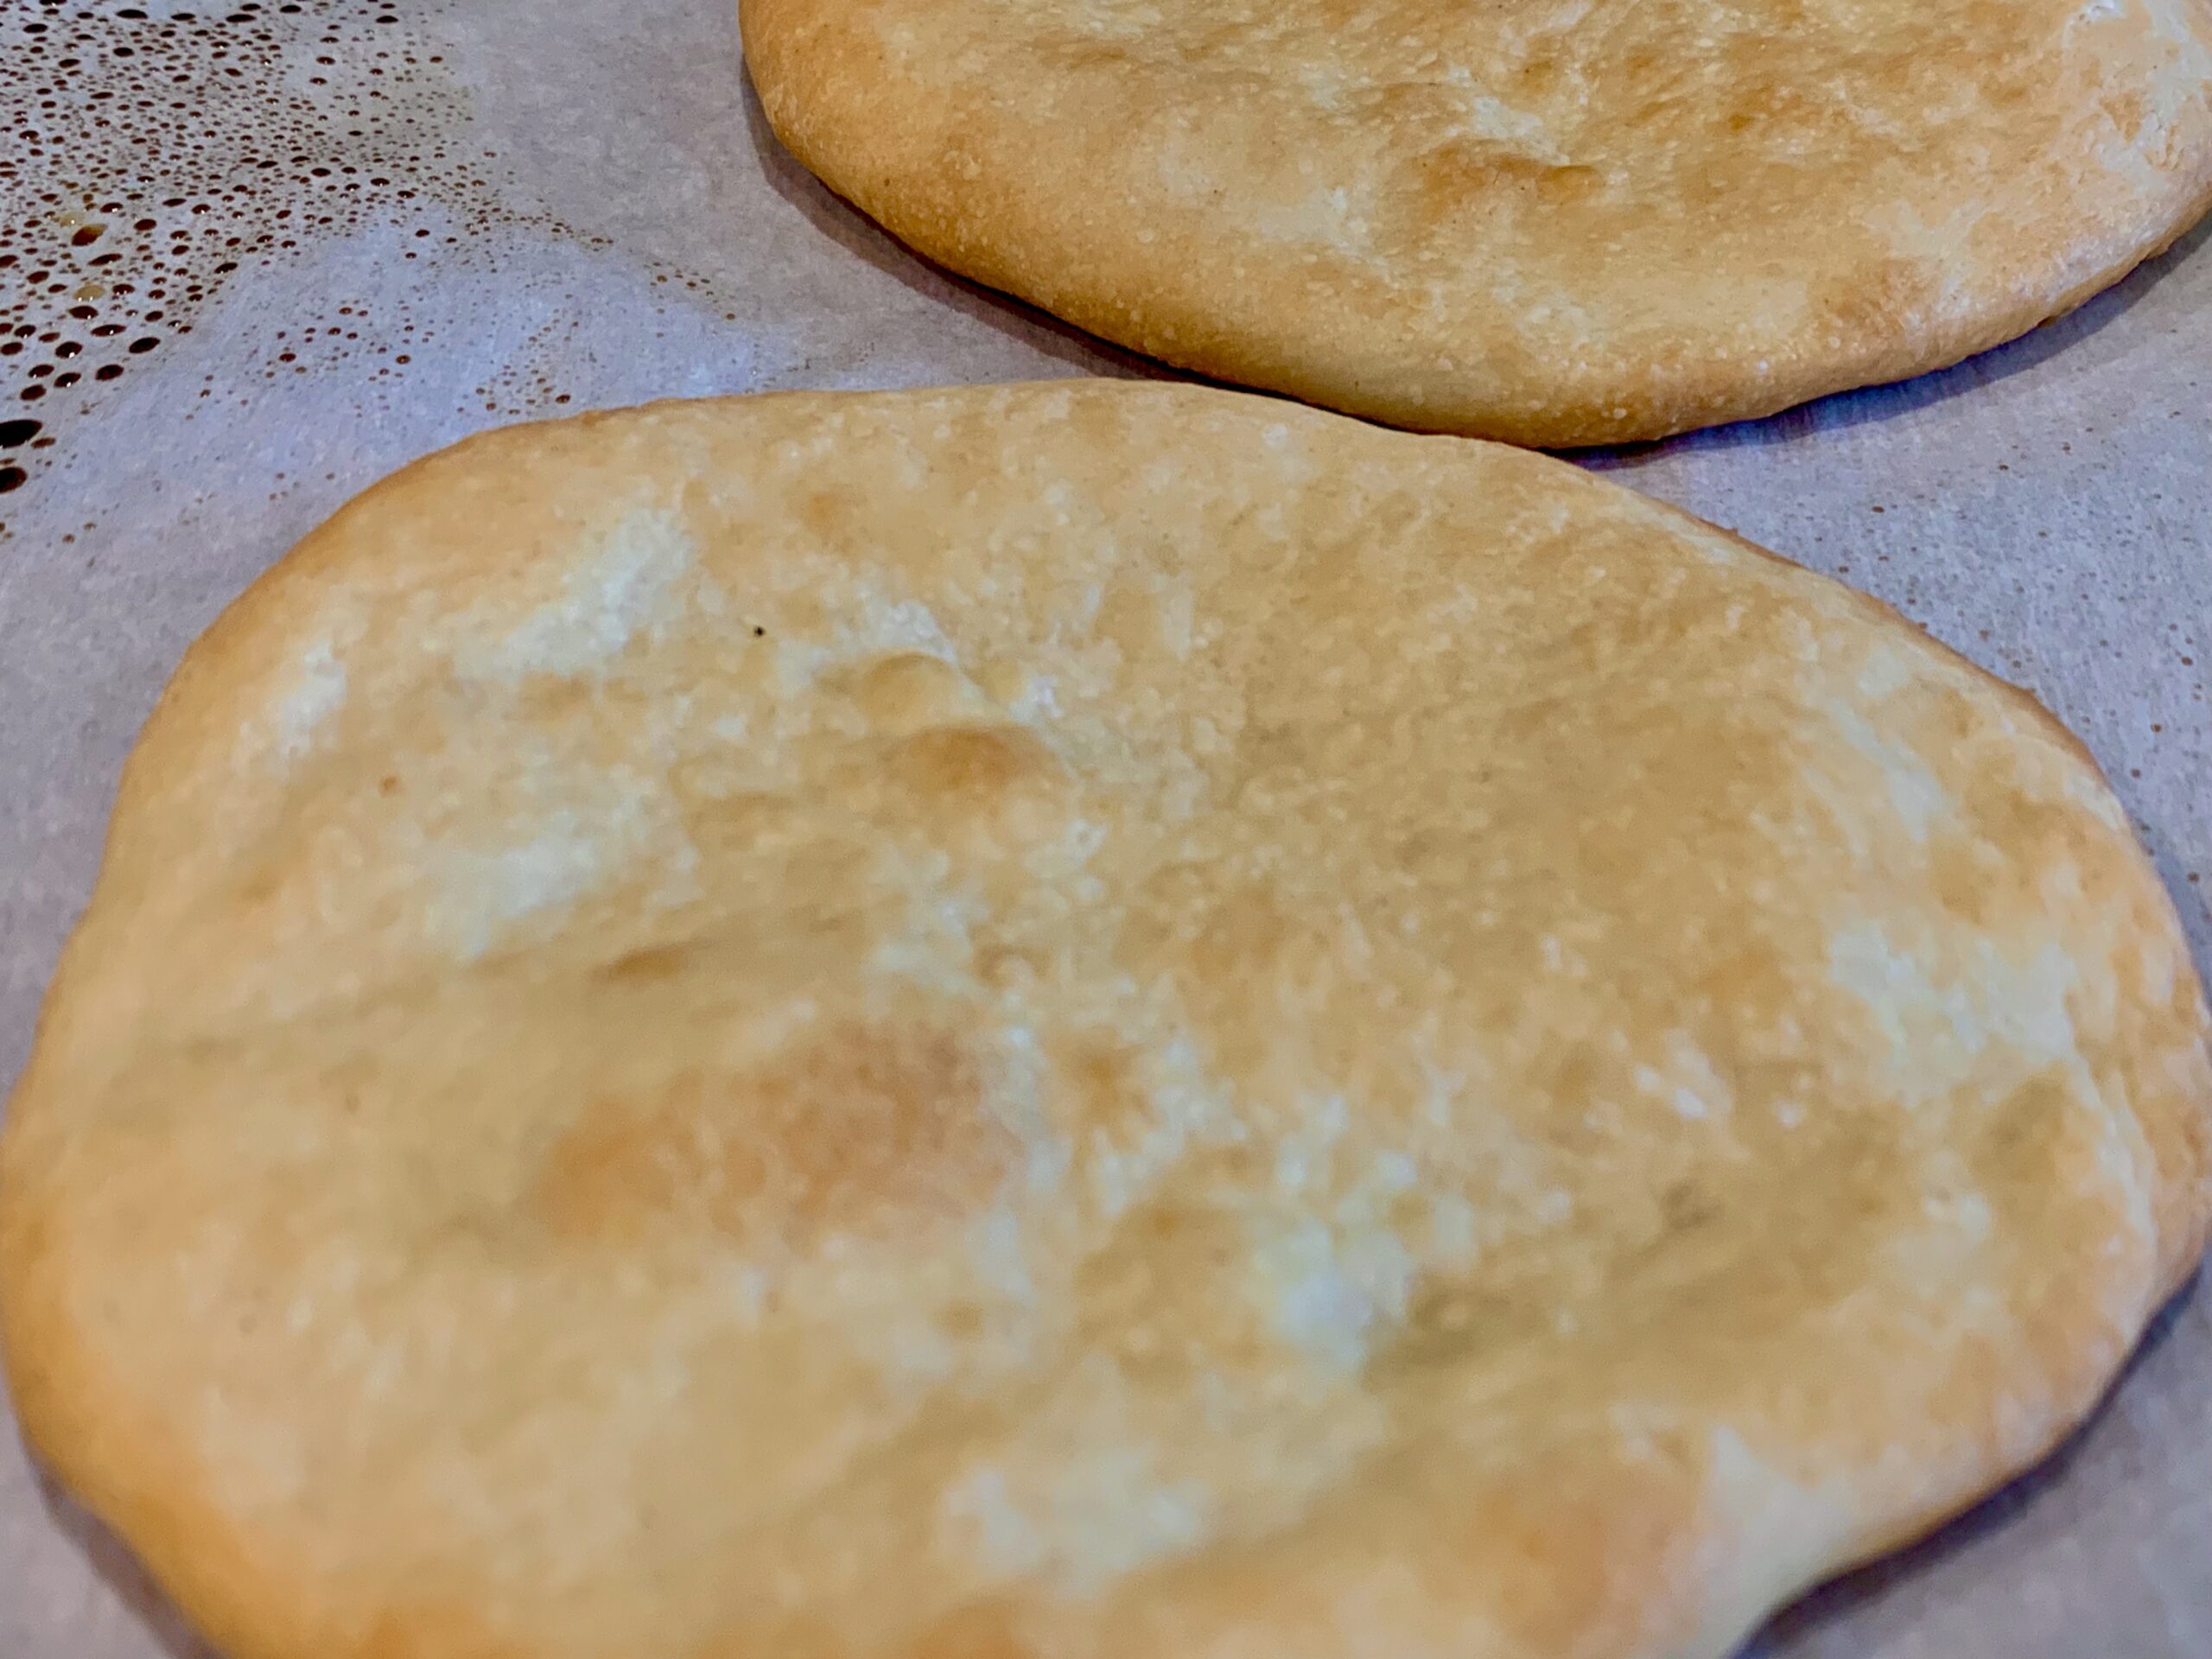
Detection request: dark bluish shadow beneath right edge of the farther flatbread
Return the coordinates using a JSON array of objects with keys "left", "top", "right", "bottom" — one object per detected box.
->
[{"left": 1592, "top": 217, "right": 2212, "bottom": 471}]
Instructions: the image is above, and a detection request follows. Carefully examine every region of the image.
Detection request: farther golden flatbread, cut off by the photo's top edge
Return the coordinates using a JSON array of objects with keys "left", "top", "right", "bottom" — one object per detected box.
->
[{"left": 741, "top": 0, "right": 2212, "bottom": 445}]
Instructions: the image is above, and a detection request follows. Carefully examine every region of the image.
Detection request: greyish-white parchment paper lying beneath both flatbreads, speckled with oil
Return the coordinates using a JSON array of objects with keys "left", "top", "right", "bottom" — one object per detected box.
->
[{"left": 0, "top": 0, "right": 2212, "bottom": 1659}]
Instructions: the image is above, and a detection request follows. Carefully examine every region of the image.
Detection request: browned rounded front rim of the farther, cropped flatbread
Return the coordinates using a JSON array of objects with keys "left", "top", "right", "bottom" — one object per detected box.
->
[{"left": 739, "top": 0, "right": 2212, "bottom": 449}]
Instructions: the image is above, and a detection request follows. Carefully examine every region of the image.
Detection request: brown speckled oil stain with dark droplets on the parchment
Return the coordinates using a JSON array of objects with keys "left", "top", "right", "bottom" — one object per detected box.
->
[{"left": 0, "top": 0, "right": 614, "bottom": 537}]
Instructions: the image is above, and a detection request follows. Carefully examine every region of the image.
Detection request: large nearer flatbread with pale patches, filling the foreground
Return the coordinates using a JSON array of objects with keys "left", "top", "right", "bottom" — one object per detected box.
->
[{"left": 0, "top": 383, "right": 2212, "bottom": 1659}]
